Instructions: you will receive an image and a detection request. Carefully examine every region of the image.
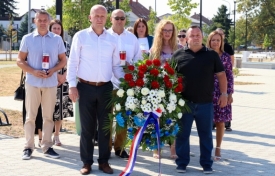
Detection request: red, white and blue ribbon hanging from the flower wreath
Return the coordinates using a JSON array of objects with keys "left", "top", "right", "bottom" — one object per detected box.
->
[{"left": 119, "top": 109, "right": 161, "bottom": 176}]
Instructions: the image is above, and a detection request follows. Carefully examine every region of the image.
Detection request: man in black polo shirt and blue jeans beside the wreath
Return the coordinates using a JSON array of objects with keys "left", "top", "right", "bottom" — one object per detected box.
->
[{"left": 173, "top": 26, "right": 227, "bottom": 174}]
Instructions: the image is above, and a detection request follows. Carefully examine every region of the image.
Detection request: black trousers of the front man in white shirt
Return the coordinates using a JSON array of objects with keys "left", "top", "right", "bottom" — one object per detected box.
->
[{"left": 77, "top": 81, "right": 113, "bottom": 165}]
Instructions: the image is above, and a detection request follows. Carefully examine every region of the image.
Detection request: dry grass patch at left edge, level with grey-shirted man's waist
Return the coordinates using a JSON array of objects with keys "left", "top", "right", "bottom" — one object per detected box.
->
[{"left": 0, "top": 67, "right": 22, "bottom": 96}]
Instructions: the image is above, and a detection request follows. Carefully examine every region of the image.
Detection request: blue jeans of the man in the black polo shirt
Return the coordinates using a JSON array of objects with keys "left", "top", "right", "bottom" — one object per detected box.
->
[{"left": 176, "top": 102, "right": 214, "bottom": 169}]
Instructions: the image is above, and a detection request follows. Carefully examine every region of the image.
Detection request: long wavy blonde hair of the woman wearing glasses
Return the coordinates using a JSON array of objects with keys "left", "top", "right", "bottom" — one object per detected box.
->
[{"left": 150, "top": 20, "right": 178, "bottom": 59}]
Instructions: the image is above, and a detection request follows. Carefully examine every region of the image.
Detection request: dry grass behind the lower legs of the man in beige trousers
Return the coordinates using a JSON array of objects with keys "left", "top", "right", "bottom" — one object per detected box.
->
[{"left": 0, "top": 109, "right": 76, "bottom": 137}]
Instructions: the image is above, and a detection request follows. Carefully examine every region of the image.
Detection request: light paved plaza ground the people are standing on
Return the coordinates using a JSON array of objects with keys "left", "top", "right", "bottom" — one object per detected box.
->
[{"left": 0, "top": 68, "right": 275, "bottom": 176}]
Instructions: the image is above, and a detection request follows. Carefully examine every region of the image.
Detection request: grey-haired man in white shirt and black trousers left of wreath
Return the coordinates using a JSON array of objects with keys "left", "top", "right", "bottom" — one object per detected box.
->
[{"left": 67, "top": 5, "right": 124, "bottom": 175}]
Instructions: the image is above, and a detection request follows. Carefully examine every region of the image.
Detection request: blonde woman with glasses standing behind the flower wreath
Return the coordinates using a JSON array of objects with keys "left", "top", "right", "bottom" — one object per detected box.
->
[{"left": 150, "top": 20, "right": 182, "bottom": 159}]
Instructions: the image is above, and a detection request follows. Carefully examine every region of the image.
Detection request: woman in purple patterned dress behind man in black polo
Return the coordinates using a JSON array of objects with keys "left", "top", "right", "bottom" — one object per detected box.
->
[{"left": 207, "top": 31, "right": 234, "bottom": 161}]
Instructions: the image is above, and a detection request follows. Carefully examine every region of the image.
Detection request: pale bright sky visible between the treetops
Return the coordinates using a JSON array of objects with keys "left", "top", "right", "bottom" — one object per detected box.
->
[{"left": 16, "top": 0, "right": 241, "bottom": 19}]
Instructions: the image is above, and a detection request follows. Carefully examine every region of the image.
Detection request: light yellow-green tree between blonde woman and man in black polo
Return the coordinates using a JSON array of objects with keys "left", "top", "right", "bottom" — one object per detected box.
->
[{"left": 167, "top": 0, "right": 198, "bottom": 30}]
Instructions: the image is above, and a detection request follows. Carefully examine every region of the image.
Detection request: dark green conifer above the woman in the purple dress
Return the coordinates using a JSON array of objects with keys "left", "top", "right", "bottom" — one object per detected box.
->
[{"left": 211, "top": 5, "right": 232, "bottom": 38}]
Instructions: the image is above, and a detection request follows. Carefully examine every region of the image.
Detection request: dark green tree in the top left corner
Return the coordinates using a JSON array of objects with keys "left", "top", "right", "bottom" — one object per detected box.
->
[{"left": 0, "top": 0, "right": 18, "bottom": 17}]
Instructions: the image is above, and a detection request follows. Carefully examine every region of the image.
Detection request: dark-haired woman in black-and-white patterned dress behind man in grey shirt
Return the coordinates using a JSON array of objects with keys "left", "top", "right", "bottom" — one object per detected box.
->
[{"left": 49, "top": 20, "right": 73, "bottom": 146}]
